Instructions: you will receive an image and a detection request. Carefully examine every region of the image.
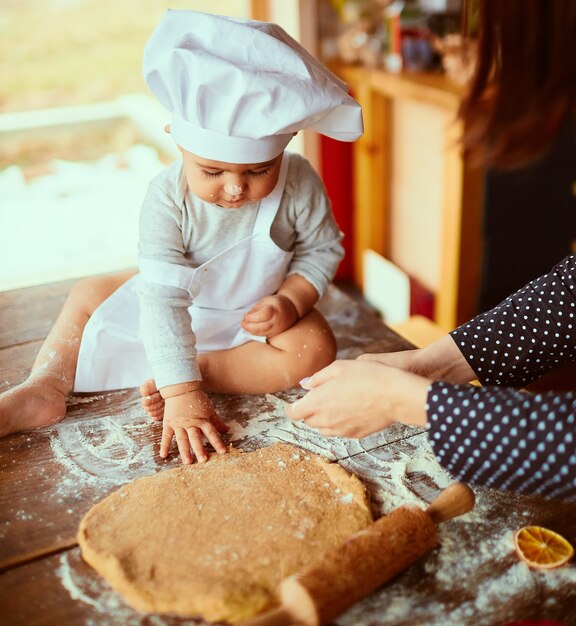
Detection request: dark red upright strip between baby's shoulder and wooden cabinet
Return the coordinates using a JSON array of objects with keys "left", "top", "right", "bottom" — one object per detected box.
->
[{"left": 320, "top": 135, "right": 354, "bottom": 280}]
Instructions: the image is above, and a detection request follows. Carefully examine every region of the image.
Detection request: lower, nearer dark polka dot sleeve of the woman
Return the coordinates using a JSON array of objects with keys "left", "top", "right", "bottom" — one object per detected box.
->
[{"left": 427, "top": 382, "right": 576, "bottom": 501}]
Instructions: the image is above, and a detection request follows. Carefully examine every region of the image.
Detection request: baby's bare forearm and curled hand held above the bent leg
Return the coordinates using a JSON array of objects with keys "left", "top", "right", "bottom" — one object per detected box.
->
[{"left": 241, "top": 274, "right": 319, "bottom": 337}]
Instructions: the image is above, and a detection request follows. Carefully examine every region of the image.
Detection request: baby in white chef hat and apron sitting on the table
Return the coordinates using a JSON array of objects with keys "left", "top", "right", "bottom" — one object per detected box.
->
[{"left": 0, "top": 10, "right": 362, "bottom": 463}]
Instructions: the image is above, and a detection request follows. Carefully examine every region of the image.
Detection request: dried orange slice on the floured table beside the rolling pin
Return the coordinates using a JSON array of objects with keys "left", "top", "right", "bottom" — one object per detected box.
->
[{"left": 514, "top": 526, "right": 574, "bottom": 569}]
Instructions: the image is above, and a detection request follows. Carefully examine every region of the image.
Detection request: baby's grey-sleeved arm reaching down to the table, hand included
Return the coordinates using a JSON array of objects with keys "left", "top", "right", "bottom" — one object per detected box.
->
[{"left": 139, "top": 163, "right": 227, "bottom": 463}]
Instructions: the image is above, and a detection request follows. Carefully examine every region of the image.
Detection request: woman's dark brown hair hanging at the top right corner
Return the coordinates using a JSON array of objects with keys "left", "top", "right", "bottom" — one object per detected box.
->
[{"left": 459, "top": 0, "right": 576, "bottom": 169}]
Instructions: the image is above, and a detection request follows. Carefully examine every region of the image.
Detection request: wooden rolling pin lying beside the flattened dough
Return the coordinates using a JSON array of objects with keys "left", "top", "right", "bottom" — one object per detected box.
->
[{"left": 239, "top": 483, "right": 474, "bottom": 626}]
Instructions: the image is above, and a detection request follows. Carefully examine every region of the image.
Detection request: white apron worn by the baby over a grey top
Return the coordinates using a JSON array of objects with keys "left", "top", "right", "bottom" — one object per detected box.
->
[{"left": 74, "top": 152, "right": 293, "bottom": 392}]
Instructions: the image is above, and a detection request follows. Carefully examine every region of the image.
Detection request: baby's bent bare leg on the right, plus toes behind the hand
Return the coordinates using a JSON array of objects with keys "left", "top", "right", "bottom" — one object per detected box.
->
[{"left": 140, "top": 309, "right": 336, "bottom": 420}]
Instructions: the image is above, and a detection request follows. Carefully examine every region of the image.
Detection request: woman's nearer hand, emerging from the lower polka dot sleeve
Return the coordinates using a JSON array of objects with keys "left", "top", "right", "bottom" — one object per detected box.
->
[{"left": 286, "top": 359, "right": 432, "bottom": 438}]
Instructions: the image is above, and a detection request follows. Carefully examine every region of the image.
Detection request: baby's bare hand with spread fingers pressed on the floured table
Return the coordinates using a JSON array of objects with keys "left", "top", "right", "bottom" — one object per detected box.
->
[{"left": 160, "top": 389, "right": 228, "bottom": 465}]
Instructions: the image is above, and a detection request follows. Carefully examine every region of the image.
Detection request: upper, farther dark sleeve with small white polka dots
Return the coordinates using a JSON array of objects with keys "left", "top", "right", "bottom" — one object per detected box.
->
[{"left": 450, "top": 255, "right": 576, "bottom": 388}]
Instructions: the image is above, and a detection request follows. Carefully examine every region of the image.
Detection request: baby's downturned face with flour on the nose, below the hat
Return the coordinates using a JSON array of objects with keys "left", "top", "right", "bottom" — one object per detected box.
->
[{"left": 180, "top": 148, "right": 282, "bottom": 209}]
